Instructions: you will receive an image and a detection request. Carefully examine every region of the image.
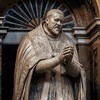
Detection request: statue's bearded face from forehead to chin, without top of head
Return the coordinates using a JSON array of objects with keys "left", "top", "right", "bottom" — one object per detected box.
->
[{"left": 47, "top": 13, "right": 64, "bottom": 36}]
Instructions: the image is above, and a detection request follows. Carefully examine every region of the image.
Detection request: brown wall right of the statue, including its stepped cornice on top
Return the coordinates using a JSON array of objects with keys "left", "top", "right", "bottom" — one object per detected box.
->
[{"left": 74, "top": 18, "right": 100, "bottom": 100}]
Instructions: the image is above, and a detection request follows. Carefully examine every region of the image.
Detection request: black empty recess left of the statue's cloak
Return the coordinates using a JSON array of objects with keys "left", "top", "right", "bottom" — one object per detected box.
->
[{"left": 2, "top": 44, "right": 18, "bottom": 100}]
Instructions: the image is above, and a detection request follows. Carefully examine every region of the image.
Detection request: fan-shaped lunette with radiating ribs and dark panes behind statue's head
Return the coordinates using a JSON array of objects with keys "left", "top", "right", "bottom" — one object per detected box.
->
[{"left": 3, "top": 0, "right": 75, "bottom": 30}]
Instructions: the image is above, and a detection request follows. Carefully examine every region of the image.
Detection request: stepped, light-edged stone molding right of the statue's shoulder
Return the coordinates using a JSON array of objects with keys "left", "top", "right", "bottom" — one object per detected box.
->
[{"left": 72, "top": 18, "right": 100, "bottom": 44}]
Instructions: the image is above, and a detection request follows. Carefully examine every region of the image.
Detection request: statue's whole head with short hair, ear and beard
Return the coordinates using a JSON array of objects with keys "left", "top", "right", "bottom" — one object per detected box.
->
[{"left": 45, "top": 9, "right": 64, "bottom": 36}]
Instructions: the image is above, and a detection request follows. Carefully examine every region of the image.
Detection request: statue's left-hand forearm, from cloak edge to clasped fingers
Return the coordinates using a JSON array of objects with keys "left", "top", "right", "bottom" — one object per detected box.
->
[{"left": 36, "top": 46, "right": 73, "bottom": 73}]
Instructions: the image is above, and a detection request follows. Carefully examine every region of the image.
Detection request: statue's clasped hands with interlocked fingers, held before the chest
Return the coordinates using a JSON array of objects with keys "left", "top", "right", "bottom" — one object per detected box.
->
[{"left": 58, "top": 46, "right": 74, "bottom": 63}]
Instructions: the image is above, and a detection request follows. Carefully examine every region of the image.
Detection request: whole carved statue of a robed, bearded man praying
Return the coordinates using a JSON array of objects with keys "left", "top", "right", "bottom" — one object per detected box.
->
[{"left": 13, "top": 9, "right": 86, "bottom": 100}]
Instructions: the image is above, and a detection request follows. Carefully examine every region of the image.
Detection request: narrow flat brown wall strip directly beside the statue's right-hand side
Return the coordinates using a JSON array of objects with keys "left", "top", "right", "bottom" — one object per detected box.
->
[{"left": 78, "top": 45, "right": 91, "bottom": 100}]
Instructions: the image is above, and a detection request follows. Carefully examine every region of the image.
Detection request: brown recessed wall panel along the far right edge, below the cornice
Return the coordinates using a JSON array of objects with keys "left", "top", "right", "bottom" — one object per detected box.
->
[{"left": 92, "top": 36, "right": 100, "bottom": 98}]
